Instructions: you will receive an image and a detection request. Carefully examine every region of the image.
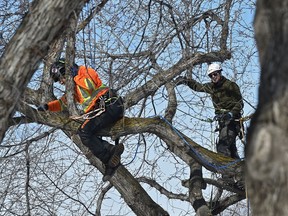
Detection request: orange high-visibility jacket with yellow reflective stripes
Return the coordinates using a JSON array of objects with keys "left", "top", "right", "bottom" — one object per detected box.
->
[{"left": 48, "top": 66, "right": 108, "bottom": 113}]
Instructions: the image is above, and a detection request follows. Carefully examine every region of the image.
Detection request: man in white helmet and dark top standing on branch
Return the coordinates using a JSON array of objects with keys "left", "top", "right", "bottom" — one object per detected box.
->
[{"left": 176, "top": 63, "right": 244, "bottom": 159}]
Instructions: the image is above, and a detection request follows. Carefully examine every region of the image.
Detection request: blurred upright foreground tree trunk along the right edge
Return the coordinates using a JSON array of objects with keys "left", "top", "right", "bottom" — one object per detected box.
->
[{"left": 247, "top": 0, "right": 288, "bottom": 215}]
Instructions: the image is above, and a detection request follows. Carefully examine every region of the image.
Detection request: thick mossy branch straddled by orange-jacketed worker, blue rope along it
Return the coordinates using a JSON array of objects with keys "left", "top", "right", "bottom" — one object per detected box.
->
[{"left": 17, "top": 101, "right": 244, "bottom": 182}]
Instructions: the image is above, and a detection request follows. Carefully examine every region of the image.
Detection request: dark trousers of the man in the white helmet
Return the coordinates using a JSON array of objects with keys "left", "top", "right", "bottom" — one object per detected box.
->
[{"left": 216, "top": 120, "right": 240, "bottom": 159}]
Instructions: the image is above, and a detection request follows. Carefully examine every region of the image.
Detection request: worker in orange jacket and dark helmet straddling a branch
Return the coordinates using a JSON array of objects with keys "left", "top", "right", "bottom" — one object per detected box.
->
[{"left": 38, "top": 59, "right": 124, "bottom": 181}]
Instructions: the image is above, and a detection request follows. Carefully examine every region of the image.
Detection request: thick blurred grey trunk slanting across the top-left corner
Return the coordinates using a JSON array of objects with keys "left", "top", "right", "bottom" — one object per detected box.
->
[{"left": 0, "top": 0, "right": 86, "bottom": 142}]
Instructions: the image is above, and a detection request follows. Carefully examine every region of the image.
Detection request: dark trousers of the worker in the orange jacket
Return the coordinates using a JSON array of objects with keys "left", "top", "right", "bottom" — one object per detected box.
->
[{"left": 78, "top": 97, "right": 124, "bottom": 163}]
